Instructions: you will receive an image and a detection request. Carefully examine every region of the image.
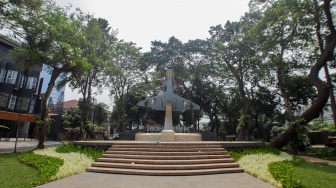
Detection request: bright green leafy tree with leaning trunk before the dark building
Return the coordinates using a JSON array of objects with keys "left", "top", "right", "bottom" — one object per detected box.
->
[{"left": 6, "top": 0, "right": 90, "bottom": 149}]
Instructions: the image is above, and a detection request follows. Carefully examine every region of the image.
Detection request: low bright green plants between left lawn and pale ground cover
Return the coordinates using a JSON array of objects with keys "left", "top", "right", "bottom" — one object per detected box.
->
[{"left": 18, "top": 152, "right": 63, "bottom": 186}]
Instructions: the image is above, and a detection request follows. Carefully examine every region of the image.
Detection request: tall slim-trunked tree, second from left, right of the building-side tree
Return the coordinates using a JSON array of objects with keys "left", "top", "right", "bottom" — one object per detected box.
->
[{"left": 63, "top": 12, "right": 116, "bottom": 139}]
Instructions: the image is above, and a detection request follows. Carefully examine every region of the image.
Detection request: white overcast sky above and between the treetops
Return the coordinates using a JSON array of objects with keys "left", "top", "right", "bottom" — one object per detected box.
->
[{"left": 56, "top": 0, "right": 249, "bottom": 108}]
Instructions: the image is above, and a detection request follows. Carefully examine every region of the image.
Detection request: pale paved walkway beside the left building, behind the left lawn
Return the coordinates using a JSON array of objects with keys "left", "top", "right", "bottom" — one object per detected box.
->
[{"left": 0, "top": 138, "right": 62, "bottom": 153}]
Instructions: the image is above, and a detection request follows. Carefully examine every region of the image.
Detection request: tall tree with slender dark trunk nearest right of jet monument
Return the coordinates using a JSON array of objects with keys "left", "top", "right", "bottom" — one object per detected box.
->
[{"left": 210, "top": 14, "right": 263, "bottom": 140}]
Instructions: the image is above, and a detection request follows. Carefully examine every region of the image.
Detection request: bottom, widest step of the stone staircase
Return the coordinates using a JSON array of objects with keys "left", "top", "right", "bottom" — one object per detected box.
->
[{"left": 87, "top": 167, "right": 244, "bottom": 176}]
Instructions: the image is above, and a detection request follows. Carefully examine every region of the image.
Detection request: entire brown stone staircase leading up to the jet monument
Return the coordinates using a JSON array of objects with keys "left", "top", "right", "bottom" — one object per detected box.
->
[{"left": 86, "top": 142, "right": 244, "bottom": 176}]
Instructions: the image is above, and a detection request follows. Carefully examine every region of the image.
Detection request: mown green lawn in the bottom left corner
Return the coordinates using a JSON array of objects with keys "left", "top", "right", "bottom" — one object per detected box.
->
[{"left": 0, "top": 153, "right": 38, "bottom": 188}]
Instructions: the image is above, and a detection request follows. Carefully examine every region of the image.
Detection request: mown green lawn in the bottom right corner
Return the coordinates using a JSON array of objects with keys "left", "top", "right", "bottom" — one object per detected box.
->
[{"left": 294, "top": 162, "right": 336, "bottom": 188}]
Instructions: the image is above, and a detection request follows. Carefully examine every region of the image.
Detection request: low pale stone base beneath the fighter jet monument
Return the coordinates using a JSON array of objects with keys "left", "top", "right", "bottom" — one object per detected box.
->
[{"left": 135, "top": 130, "right": 202, "bottom": 142}]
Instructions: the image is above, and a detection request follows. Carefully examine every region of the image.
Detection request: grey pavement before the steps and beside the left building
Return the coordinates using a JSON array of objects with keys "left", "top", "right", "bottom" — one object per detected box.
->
[{"left": 0, "top": 138, "right": 273, "bottom": 188}]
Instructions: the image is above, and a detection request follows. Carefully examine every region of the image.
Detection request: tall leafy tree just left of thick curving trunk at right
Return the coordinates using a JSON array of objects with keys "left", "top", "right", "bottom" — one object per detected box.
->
[{"left": 251, "top": 0, "right": 313, "bottom": 121}]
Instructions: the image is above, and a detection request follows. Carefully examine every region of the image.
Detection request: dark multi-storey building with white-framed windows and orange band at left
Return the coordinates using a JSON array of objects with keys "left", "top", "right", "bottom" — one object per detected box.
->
[{"left": 0, "top": 35, "right": 43, "bottom": 137}]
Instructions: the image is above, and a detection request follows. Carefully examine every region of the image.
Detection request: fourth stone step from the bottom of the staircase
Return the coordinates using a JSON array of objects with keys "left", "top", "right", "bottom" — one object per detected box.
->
[{"left": 105, "top": 150, "right": 228, "bottom": 156}]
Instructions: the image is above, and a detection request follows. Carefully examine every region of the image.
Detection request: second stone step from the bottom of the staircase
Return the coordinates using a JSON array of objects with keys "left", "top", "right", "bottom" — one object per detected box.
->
[{"left": 92, "top": 162, "right": 239, "bottom": 170}]
